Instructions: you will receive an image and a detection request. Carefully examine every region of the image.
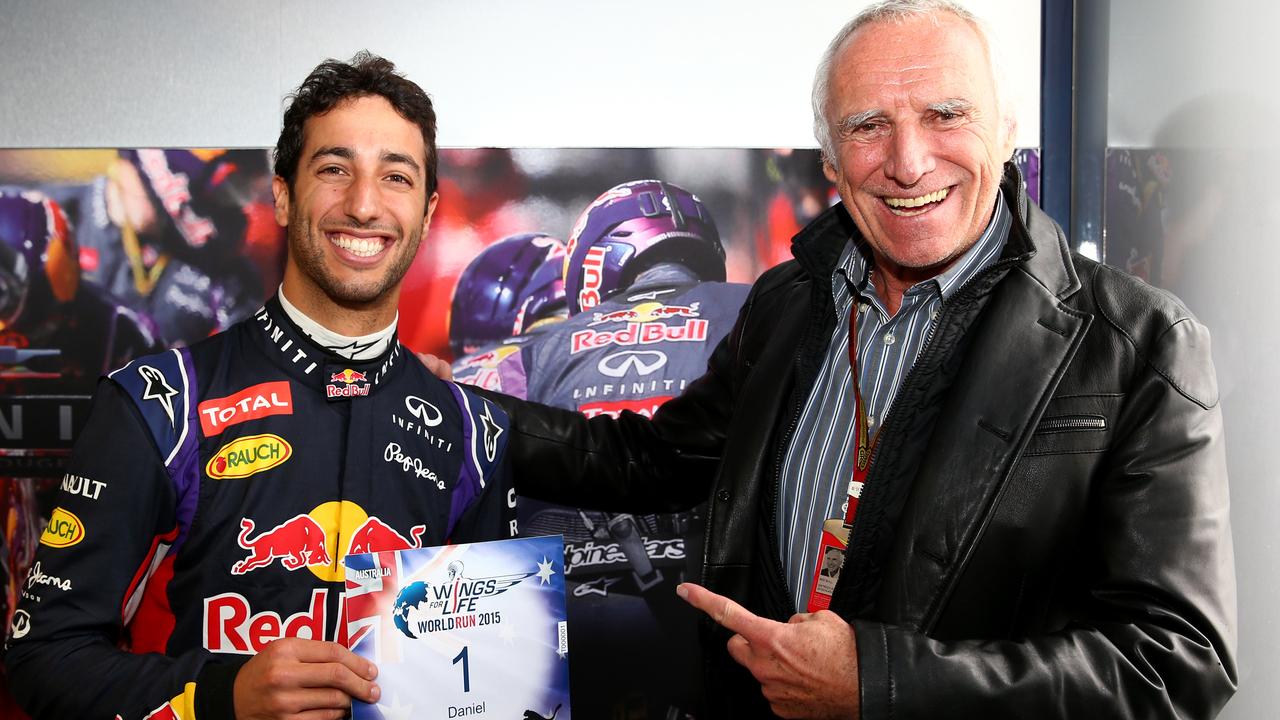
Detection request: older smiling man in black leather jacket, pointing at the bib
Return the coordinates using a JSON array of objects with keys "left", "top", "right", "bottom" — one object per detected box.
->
[{"left": 465, "top": 0, "right": 1236, "bottom": 719}]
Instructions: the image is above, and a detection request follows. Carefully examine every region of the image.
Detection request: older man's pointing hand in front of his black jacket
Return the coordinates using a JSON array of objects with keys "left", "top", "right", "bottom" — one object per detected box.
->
[{"left": 676, "top": 583, "right": 861, "bottom": 720}]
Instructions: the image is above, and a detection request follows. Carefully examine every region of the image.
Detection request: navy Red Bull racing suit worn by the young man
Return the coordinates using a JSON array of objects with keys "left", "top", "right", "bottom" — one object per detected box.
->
[{"left": 5, "top": 299, "right": 516, "bottom": 720}]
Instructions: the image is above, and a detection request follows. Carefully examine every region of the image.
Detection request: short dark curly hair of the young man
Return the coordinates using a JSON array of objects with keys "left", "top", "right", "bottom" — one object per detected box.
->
[{"left": 275, "top": 50, "right": 439, "bottom": 197}]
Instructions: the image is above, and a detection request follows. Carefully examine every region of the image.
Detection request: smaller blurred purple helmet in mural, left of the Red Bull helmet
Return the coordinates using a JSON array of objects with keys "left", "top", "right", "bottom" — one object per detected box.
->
[{"left": 449, "top": 232, "right": 564, "bottom": 356}]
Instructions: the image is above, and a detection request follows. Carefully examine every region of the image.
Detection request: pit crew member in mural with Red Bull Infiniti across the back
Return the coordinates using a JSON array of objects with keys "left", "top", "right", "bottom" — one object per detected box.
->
[{"left": 512, "top": 179, "right": 749, "bottom": 717}]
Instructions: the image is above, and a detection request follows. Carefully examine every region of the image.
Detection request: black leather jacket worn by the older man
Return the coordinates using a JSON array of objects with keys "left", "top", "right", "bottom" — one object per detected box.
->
[{"left": 494, "top": 169, "right": 1236, "bottom": 720}]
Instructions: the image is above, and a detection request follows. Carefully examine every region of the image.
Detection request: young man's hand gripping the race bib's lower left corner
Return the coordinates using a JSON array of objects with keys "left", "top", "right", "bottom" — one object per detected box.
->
[{"left": 234, "top": 638, "right": 380, "bottom": 720}]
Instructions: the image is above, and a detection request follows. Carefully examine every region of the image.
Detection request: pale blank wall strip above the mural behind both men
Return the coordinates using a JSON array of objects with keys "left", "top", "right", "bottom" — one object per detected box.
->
[{"left": 0, "top": 0, "right": 1039, "bottom": 147}]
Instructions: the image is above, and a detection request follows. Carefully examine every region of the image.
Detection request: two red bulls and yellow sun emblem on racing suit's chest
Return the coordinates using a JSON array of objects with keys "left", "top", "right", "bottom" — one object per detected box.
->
[{"left": 232, "top": 500, "right": 426, "bottom": 582}]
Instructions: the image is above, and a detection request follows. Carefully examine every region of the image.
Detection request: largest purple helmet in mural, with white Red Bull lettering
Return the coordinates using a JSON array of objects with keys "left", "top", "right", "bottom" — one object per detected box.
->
[{"left": 564, "top": 179, "right": 724, "bottom": 315}]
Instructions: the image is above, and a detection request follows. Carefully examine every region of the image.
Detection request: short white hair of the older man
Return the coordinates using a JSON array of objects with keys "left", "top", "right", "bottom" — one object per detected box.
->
[{"left": 813, "top": 0, "right": 1011, "bottom": 168}]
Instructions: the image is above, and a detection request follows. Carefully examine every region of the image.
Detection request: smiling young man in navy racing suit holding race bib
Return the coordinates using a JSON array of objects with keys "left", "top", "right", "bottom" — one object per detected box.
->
[{"left": 5, "top": 53, "right": 515, "bottom": 720}]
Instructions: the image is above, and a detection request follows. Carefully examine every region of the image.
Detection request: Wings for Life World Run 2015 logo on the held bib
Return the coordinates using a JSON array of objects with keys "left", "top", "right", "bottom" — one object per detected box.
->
[{"left": 392, "top": 557, "right": 556, "bottom": 639}]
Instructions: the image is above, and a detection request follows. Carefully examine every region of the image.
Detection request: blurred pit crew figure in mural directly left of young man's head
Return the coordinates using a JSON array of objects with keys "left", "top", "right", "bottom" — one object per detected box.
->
[{"left": 38, "top": 147, "right": 269, "bottom": 347}]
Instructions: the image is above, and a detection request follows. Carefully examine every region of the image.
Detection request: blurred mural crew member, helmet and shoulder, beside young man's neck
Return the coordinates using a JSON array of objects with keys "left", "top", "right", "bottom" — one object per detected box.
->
[{"left": 449, "top": 232, "right": 568, "bottom": 397}]
